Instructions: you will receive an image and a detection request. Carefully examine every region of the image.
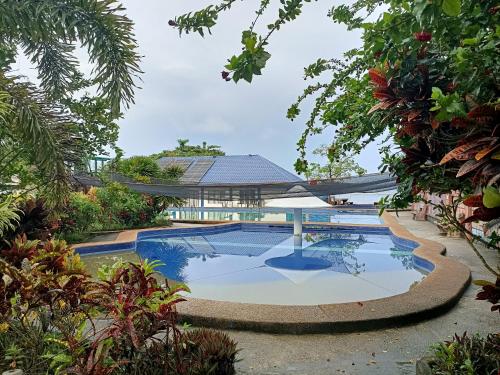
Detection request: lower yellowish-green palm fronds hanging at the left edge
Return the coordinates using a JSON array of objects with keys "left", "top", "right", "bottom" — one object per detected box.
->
[{"left": 0, "top": 71, "right": 81, "bottom": 204}]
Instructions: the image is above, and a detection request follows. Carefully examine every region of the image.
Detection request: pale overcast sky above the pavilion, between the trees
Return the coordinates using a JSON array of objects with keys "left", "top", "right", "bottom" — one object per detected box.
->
[{"left": 13, "top": 0, "right": 380, "bottom": 176}]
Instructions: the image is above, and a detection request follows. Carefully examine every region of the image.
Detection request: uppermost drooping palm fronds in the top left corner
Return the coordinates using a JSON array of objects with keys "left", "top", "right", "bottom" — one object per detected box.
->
[{"left": 0, "top": 0, "right": 142, "bottom": 113}]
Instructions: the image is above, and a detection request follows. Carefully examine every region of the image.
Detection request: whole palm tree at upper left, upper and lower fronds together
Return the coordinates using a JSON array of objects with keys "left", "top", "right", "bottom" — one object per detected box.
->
[{"left": 0, "top": 0, "right": 141, "bottom": 206}]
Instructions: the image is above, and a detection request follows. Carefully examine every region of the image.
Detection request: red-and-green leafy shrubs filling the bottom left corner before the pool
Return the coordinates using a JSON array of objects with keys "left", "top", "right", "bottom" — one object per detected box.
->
[{"left": 0, "top": 237, "right": 237, "bottom": 375}]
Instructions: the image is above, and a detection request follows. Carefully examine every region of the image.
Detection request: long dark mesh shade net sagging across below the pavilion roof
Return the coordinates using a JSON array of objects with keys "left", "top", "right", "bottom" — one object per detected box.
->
[{"left": 73, "top": 174, "right": 397, "bottom": 201}]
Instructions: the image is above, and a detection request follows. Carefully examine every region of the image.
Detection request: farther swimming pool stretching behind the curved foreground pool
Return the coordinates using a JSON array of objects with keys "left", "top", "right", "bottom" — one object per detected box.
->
[{"left": 167, "top": 207, "right": 382, "bottom": 224}]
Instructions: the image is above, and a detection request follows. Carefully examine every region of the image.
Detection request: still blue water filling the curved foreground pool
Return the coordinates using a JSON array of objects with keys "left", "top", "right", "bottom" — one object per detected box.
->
[{"left": 129, "top": 224, "right": 430, "bottom": 305}]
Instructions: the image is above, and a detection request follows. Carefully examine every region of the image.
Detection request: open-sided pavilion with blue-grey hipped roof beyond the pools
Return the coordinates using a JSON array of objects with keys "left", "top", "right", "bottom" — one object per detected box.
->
[{"left": 158, "top": 155, "right": 302, "bottom": 207}]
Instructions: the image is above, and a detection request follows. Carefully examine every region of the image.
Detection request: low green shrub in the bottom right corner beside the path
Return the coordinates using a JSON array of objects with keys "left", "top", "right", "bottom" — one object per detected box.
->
[{"left": 431, "top": 333, "right": 500, "bottom": 375}]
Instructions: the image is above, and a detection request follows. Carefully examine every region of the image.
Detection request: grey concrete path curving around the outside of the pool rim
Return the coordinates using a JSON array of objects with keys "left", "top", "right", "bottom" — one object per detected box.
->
[{"left": 227, "top": 212, "right": 500, "bottom": 375}]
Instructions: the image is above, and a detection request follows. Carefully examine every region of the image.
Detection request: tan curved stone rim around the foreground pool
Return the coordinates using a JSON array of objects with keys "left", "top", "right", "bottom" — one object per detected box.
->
[{"left": 74, "top": 212, "right": 471, "bottom": 334}]
